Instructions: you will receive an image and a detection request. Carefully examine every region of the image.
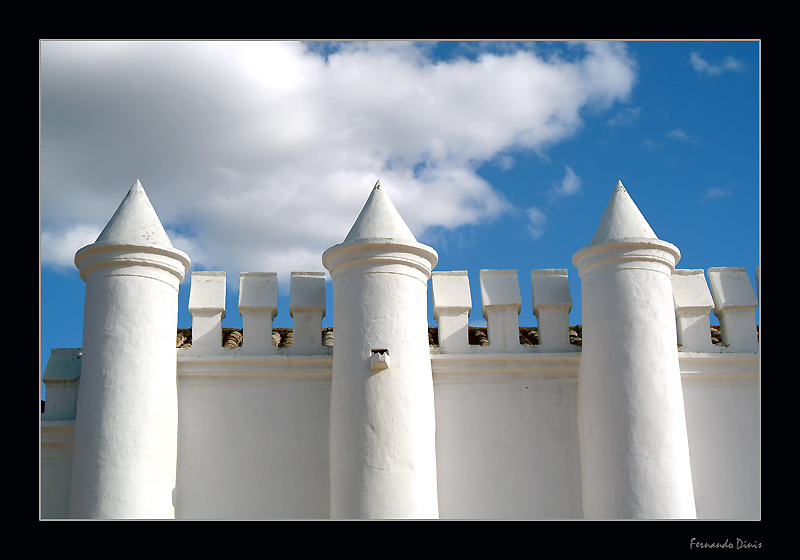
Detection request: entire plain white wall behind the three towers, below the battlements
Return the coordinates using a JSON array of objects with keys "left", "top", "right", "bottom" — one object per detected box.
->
[{"left": 41, "top": 347, "right": 761, "bottom": 519}]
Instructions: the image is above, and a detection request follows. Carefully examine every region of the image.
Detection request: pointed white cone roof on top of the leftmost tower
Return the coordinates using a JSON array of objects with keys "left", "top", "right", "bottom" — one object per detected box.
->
[{"left": 95, "top": 179, "right": 172, "bottom": 247}]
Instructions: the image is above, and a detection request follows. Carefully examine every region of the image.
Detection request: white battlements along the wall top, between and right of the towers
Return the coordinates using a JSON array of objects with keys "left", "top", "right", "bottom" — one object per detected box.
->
[{"left": 176, "top": 267, "right": 758, "bottom": 356}]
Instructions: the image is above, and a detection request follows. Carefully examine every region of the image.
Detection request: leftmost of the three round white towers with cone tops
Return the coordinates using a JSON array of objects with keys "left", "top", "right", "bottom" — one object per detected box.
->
[{"left": 70, "top": 181, "right": 190, "bottom": 519}]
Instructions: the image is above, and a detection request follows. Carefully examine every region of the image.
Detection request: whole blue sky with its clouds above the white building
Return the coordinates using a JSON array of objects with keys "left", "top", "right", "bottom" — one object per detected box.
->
[{"left": 39, "top": 41, "right": 761, "bottom": 375}]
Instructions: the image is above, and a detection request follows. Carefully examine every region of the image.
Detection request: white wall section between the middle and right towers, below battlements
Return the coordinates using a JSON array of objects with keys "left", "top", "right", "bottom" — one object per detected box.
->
[{"left": 432, "top": 354, "right": 582, "bottom": 519}]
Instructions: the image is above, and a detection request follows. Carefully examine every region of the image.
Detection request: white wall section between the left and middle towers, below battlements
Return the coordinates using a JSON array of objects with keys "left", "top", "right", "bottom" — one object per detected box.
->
[{"left": 176, "top": 356, "right": 331, "bottom": 519}]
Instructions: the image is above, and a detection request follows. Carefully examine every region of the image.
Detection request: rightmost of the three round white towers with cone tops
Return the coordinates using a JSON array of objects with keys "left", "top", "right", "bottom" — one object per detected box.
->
[{"left": 573, "top": 182, "right": 696, "bottom": 519}]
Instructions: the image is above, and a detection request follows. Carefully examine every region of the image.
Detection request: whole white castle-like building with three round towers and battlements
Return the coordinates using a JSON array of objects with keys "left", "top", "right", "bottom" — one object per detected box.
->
[{"left": 41, "top": 182, "right": 761, "bottom": 519}]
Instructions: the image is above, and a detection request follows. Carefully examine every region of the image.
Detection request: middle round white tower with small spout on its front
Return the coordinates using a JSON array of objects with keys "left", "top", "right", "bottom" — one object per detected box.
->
[{"left": 322, "top": 182, "right": 439, "bottom": 519}]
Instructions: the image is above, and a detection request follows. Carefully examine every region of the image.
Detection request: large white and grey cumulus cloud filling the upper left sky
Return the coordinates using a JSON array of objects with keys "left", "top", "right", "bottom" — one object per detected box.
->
[{"left": 40, "top": 41, "right": 635, "bottom": 284}]
